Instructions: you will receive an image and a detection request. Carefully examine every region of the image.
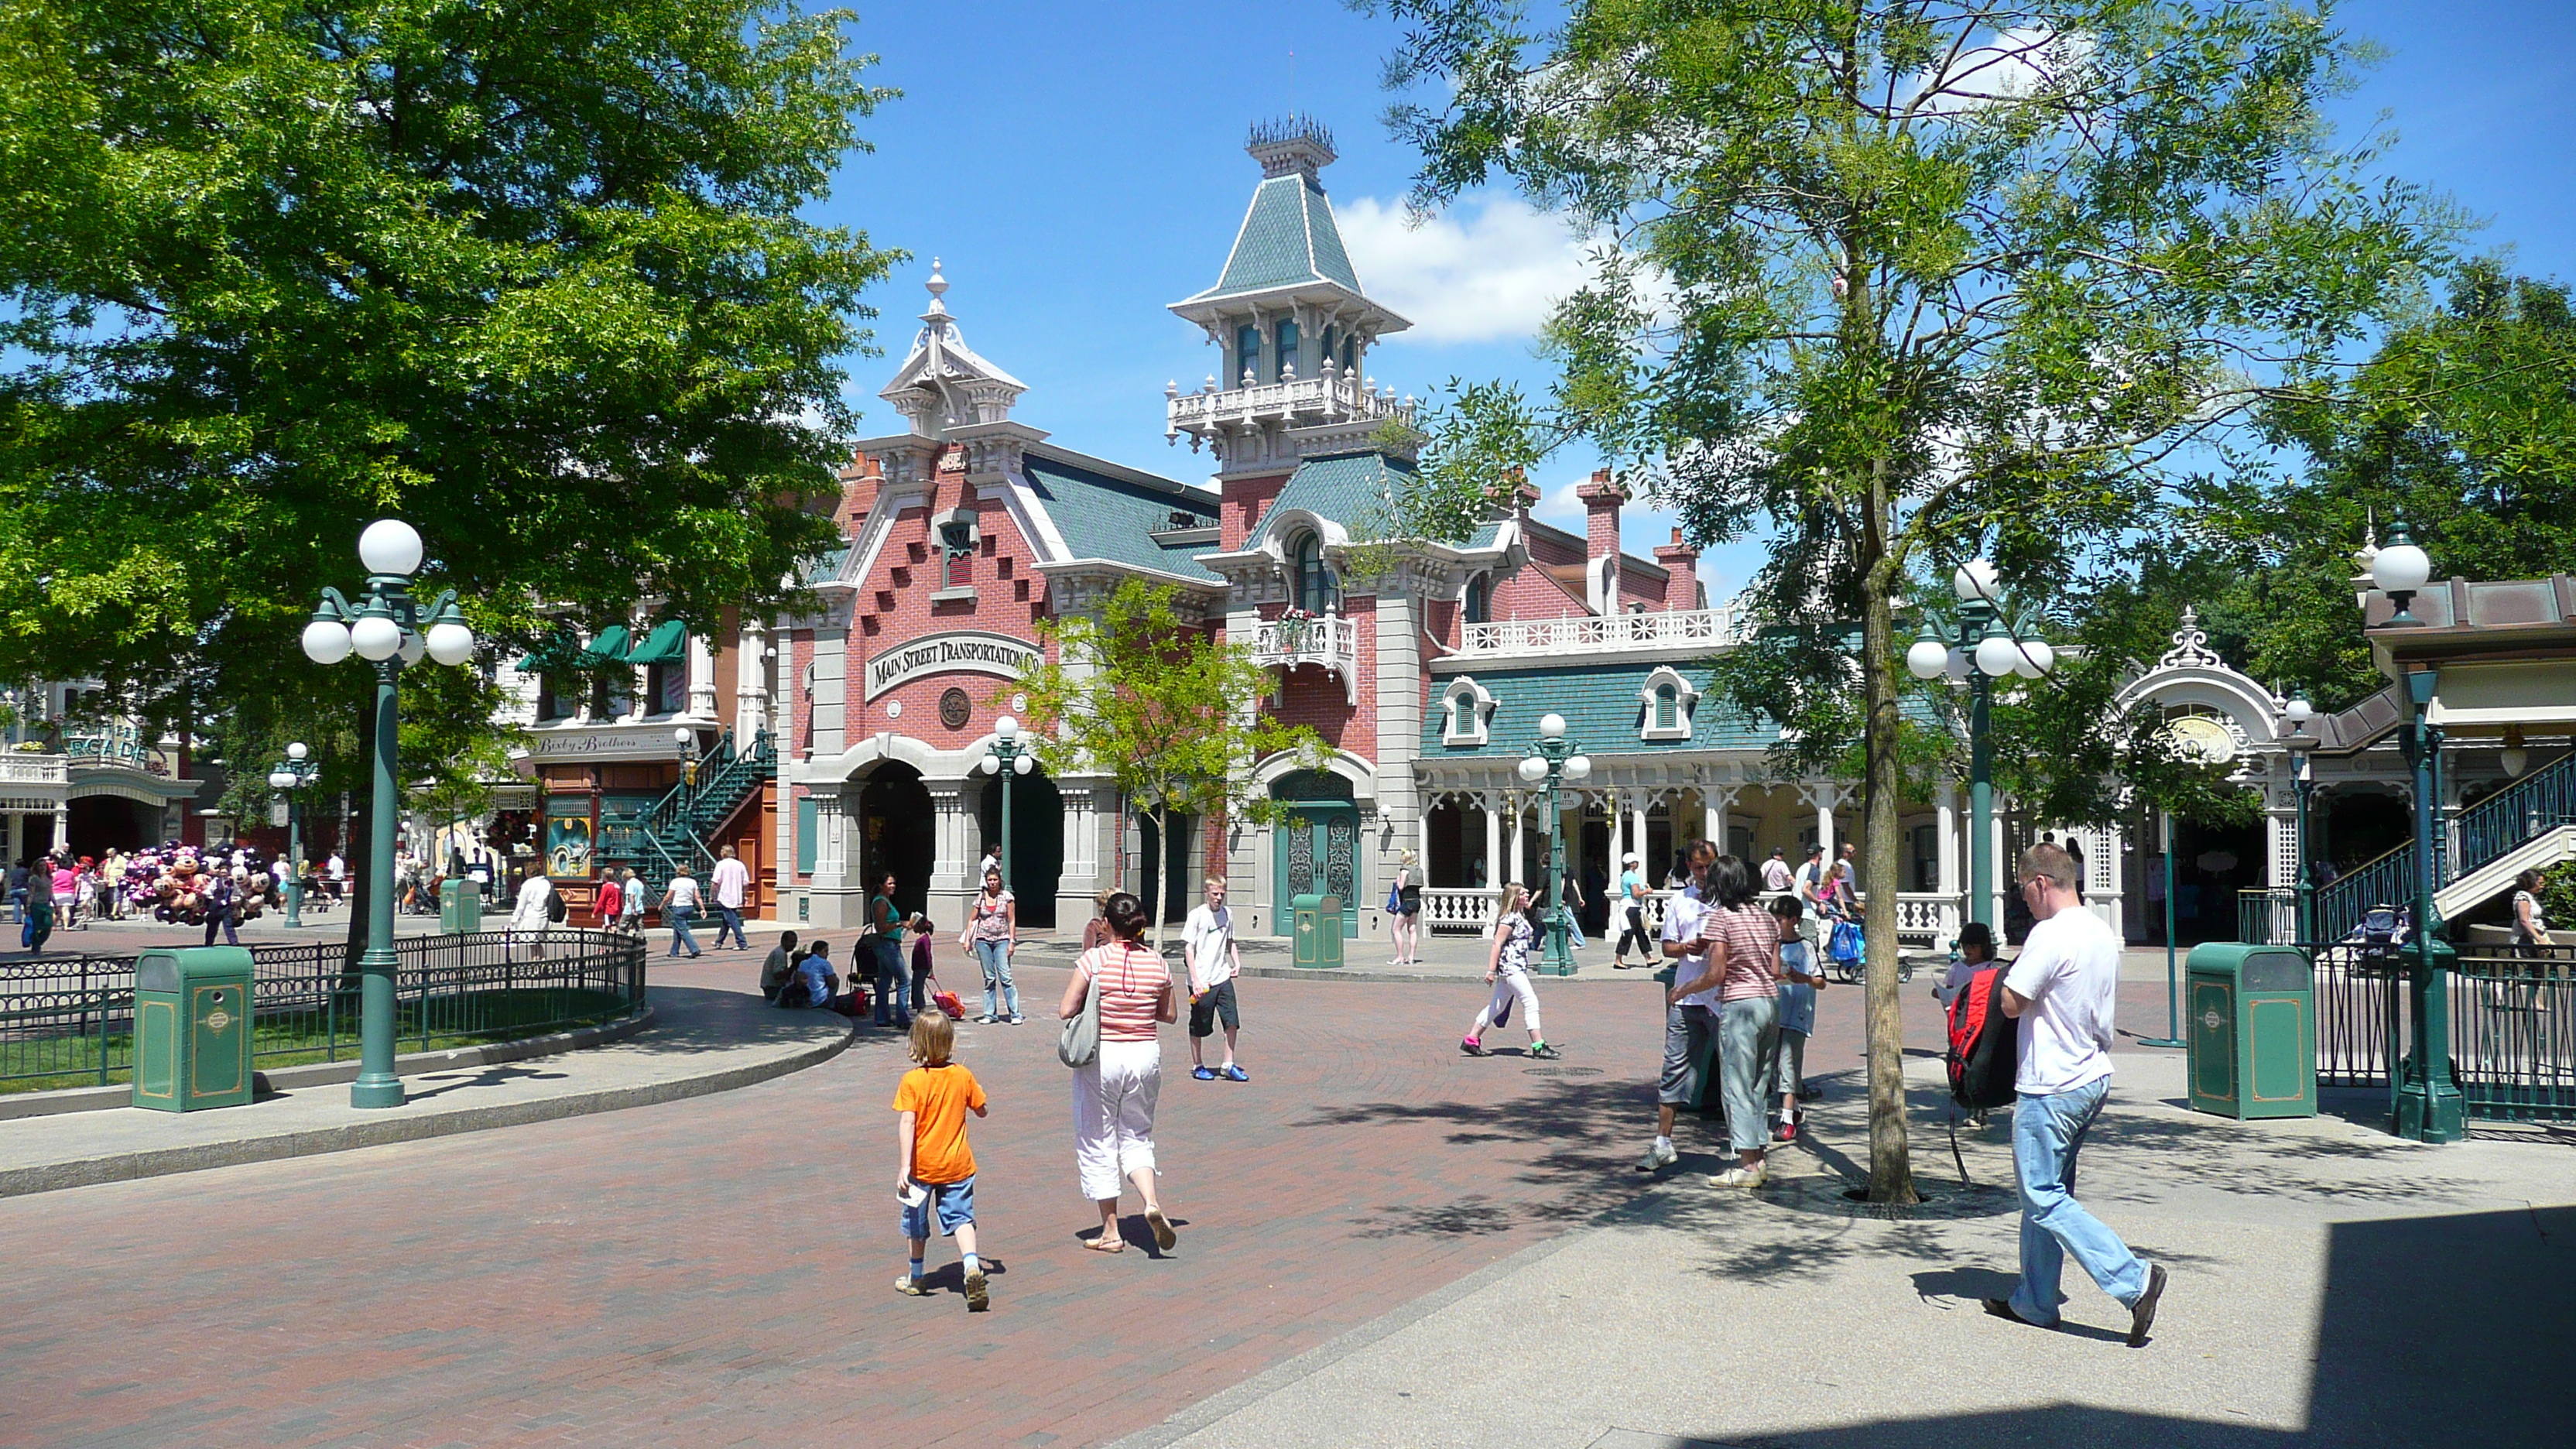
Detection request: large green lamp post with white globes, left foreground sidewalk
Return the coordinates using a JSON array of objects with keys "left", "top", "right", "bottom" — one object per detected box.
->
[{"left": 304, "top": 519, "right": 474, "bottom": 1106}]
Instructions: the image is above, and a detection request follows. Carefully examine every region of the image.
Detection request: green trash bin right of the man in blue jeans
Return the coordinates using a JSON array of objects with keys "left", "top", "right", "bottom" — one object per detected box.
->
[{"left": 2182, "top": 941, "right": 2316, "bottom": 1119}]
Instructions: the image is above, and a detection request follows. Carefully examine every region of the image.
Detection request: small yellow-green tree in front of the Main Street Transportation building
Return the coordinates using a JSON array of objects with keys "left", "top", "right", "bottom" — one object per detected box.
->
[{"left": 1012, "top": 577, "right": 1324, "bottom": 949}]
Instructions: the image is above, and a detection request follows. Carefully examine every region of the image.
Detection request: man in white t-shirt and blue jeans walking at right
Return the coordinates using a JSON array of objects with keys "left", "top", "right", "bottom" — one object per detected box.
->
[{"left": 1986, "top": 843, "right": 2164, "bottom": 1348}]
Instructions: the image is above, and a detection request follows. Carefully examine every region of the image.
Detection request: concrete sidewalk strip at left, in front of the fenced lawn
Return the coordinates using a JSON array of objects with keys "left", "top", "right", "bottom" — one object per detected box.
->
[{"left": 0, "top": 961, "right": 858, "bottom": 1197}]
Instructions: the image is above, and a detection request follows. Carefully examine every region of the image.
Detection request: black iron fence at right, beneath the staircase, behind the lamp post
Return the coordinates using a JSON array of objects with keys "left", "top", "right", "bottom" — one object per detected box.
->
[{"left": 2316, "top": 944, "right": 2576, "bottom": 1122}]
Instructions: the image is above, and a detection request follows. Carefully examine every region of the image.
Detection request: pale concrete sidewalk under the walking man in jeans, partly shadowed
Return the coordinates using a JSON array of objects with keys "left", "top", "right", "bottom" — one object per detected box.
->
[{"left": 1118, "top": 1054, "right": 2576, "bottom": 1449}]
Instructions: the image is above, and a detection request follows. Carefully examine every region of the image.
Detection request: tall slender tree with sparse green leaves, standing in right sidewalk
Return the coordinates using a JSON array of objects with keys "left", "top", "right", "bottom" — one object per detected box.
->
[{"left": 1386, "top": 0, "right": 2442, "bottom": 1201}]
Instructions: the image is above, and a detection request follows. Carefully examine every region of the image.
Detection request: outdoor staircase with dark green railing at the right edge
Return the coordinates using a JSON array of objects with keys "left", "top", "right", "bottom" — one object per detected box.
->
[{"left": 2316, "top": 755, "right": 2576, "bottom": 941}]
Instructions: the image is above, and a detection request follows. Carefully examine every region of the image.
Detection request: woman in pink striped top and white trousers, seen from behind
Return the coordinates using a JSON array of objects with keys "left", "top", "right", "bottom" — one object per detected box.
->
[{"left": 1056, "top": 889, "right": 1180, "bottom": 1253}]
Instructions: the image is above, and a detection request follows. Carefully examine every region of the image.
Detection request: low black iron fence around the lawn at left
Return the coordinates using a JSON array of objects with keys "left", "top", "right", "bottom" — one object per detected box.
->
[{"left": 0, "top": 928, "right": 646, "bottom": 1091}]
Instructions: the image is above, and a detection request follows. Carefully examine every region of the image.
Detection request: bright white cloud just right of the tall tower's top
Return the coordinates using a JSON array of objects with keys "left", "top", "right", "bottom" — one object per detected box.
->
[{"left": 1334, "top": 196, "right": 1589, "bottom": 343}]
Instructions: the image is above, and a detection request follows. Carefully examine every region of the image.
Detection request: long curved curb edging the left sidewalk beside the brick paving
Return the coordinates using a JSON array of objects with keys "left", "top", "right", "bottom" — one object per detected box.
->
[{"left": 0, "top": 1023, "right": 858, "bottom": 1197}]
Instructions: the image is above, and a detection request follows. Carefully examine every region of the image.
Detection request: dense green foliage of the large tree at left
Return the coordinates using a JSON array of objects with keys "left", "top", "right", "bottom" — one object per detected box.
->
[{"left": 0, "top": 0, "right": 894, "bottom": 737}]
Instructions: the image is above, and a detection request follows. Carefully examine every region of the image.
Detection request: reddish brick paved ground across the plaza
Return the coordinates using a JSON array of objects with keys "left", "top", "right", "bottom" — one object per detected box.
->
[{"left": 0, "top": 938, "right": 2161, "bottom": 1447}]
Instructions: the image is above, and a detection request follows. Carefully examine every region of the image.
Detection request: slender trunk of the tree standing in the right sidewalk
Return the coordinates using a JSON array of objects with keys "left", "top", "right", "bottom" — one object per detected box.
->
[{"left": 1860, "top": 459, "right": 1922, "bottom": 1204}]
